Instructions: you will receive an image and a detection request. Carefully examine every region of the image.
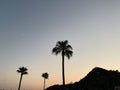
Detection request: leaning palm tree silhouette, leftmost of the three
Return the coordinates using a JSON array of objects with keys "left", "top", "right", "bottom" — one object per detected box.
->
[{"left": 17, "top": 67, "right": 28, "bottom": 90}]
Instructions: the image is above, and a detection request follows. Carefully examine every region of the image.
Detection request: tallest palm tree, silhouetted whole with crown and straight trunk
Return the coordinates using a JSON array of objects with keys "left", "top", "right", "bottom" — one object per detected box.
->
[{"left": 52, "top": 40, "right": 73, "bottom": 85}]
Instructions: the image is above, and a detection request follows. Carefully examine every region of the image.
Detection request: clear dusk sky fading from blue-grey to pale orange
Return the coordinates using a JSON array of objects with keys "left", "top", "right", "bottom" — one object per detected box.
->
[{"left": 0, "top": 0, "right": 120, "bottom": 90}]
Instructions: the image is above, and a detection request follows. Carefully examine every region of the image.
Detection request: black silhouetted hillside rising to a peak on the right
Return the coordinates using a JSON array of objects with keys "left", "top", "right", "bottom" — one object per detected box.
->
[{"left": 46, "top": 67, "right": 120, "bottom": 90}]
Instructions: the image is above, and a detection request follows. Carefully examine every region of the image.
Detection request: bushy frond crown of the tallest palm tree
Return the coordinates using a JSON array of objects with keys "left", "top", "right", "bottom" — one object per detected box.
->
[{"left": 52, "top": 40, "right": 73, "bottom": 59}]
